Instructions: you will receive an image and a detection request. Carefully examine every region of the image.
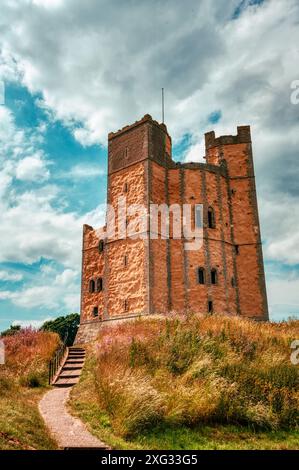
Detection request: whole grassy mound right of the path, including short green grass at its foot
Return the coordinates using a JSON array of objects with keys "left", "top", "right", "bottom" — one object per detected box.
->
[{"left": 70, "top": 316, "right": 299, "bottom": 449}]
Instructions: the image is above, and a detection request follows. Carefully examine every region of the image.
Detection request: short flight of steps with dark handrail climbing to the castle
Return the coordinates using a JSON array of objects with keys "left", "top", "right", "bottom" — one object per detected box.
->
[{"left": 53, "top": 346, "right": 85, "bottom": 387}]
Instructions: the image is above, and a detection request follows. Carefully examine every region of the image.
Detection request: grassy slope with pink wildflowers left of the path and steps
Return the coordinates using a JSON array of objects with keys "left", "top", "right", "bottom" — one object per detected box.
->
[{"left": 0, "top": 329, "right": 59, "bottom": 450}]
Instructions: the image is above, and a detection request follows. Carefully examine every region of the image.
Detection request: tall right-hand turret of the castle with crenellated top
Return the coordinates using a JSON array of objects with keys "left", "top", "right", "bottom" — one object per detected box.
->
[{"left": 205, "top": 126, "right": 268, "bottom": 320}]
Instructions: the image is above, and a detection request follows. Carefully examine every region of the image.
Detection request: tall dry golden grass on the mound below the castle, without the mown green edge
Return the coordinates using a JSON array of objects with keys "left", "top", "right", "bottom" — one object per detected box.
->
[{"left": 95, "top": 316, "right": 299, "bottom": 436}]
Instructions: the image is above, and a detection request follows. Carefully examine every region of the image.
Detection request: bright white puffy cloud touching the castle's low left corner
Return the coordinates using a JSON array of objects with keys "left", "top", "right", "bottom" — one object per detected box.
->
[{"left": 0, "top": 192, "right": 105, "bottom": 268}]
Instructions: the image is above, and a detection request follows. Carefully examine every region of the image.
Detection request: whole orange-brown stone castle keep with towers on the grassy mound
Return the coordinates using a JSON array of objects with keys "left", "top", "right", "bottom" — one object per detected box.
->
[{"left": 77, "top": 115, "right": 268, "bottom": 342}]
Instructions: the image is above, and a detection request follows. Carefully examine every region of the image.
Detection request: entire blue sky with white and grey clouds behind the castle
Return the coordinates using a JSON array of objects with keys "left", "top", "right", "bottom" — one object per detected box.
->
[{"left": 0, "top": 0, "right": 299, "bottom": 330}]
